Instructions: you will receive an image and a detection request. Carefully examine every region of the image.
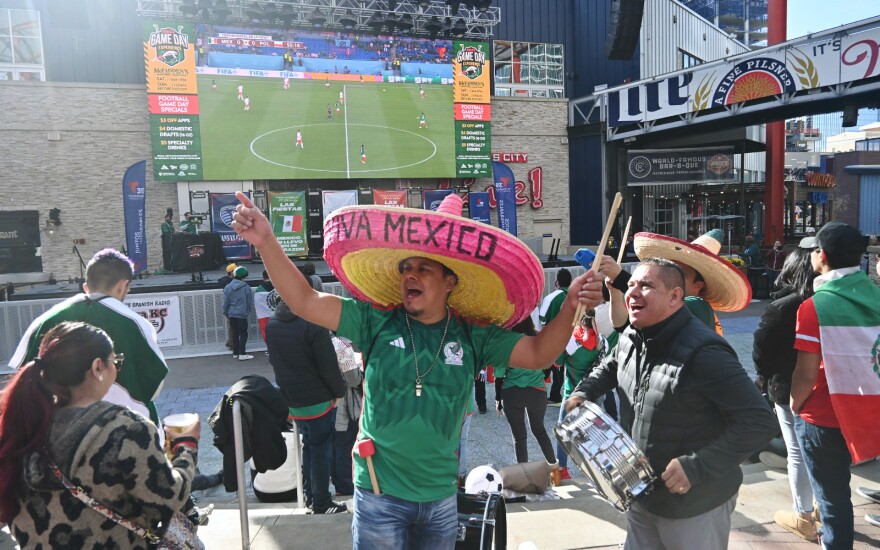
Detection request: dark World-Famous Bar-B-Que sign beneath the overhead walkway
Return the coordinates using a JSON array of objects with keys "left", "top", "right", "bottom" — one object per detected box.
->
[{"left": 627, "top": 147, "right": 735, "bottom": 186}]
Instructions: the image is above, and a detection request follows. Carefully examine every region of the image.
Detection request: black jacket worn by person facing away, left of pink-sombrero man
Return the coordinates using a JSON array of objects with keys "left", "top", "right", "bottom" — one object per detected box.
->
[{"left": 266, "top": 305, "right": 346, "bottom": 407}]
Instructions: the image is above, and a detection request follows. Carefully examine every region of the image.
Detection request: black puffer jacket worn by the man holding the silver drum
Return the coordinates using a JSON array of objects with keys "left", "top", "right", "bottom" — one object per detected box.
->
[{"left": 572, "top": 307, "right": 778, "bottom": 518}]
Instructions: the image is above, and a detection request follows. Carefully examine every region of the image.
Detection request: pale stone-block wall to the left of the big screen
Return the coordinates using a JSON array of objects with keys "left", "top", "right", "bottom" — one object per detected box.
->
[{"left": 0, "top": 82, "right": 171, "bottom": 280}]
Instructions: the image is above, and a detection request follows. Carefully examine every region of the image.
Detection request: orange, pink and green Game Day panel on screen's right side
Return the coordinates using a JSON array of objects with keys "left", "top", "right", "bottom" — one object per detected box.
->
[{"left": 453, "top": 41, "right": 492, "bottom": 178}]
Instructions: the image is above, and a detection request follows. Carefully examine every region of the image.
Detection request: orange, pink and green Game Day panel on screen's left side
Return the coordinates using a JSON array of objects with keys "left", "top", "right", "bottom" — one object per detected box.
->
[{"left": 144, "top": 21, "right": 202, "bottom": 181}]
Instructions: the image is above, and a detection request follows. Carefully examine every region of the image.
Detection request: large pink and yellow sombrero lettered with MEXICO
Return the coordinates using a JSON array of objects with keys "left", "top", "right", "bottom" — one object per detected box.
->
[{"left": 324, "top": 193, "right": 544, "bottom": 327}]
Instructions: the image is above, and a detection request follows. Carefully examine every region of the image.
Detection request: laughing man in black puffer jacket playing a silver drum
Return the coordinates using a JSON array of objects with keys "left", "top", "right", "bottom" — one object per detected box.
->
[{"left": 566, "top": 258, "right": 778, "bottom": 550}]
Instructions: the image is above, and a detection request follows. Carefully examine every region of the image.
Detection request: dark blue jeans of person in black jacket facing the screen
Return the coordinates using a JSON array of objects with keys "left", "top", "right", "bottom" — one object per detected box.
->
[{"left": 296, "top": 408, "right": 336, "bottom": 508}]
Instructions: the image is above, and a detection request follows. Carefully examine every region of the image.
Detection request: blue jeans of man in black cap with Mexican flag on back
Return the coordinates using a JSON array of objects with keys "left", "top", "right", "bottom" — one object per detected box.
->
[{"left": 794, "top": 416, "right": 855, "bottom": 550}]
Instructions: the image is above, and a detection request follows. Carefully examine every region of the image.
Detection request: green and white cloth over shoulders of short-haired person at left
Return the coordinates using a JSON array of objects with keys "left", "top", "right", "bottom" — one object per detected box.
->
[{"left": 9, "top": 294, "right": 168, "bottom": 426}]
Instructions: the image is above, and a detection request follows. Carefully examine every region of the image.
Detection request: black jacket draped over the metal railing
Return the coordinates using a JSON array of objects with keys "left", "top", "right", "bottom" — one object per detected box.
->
[{"left": 208, "top": 375, "right": 288, "bottom": 491}]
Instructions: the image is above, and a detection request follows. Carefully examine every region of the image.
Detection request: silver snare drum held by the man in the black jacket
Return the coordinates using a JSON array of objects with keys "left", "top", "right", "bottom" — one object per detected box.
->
[{"left": 554, "top": 401, "right": 656, "bottom": 512}]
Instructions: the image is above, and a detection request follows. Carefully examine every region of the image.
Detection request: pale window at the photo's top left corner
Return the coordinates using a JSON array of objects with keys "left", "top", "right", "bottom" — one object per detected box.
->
[{"left": 0, "top": 8, "right": 46, "bottom": 81}]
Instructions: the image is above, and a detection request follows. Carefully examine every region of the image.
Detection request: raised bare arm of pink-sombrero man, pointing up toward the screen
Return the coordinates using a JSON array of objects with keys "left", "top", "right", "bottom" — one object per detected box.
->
[{"left": 232, "top": 191, "right": 342, "bottom": 330}]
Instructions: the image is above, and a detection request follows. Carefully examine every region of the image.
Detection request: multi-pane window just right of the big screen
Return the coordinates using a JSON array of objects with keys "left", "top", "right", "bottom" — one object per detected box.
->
[{"left": 493, "top": 40, "right": 565, "bottom": 98}]
